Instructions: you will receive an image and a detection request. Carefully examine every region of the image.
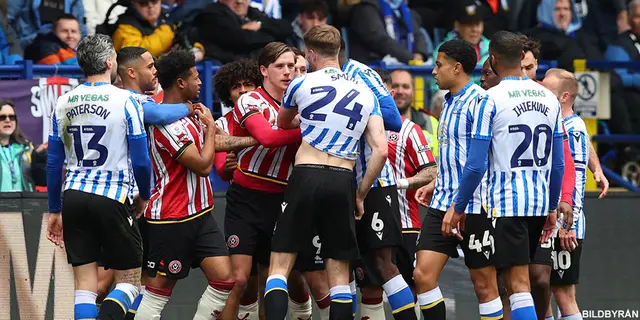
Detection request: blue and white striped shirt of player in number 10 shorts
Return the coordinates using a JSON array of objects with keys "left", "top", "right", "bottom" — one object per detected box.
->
[{"left": 558, "top": 114, "right": 590, "bottom": 239}]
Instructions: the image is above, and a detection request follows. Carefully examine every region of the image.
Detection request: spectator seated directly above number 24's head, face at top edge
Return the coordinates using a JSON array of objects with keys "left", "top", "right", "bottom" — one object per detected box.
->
[{"left": 289, "top": 0, "right": 329, "bottom": 50}]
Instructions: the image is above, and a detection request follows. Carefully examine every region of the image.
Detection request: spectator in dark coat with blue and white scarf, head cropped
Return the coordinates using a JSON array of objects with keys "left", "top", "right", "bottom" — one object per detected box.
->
[{"left": 349, "top": 0, "right": 429, "bottom": 63}]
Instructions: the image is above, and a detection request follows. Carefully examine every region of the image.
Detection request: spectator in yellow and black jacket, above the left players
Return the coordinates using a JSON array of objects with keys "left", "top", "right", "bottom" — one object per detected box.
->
[{"left": 113, "top": 0, "right": 185, "bottom": 57}]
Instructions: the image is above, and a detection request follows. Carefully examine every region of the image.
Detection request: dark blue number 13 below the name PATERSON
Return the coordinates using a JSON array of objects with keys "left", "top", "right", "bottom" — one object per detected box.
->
[{"left": 67, "top": 126, "right": 109, "bottom": 167}]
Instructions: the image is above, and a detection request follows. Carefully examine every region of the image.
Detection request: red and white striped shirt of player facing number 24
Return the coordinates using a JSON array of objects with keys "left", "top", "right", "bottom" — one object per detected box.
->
[{"left": 232, "top": 87, "right": 298, "bottom": 192}]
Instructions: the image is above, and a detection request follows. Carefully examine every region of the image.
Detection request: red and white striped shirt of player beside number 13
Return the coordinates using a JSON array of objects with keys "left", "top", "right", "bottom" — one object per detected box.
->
[{"left": 144, "top": 116, "right": 213, "bottom": 223}]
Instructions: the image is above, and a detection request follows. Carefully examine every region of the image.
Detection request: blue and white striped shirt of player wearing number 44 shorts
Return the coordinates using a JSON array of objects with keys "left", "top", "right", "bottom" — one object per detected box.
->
[{"left": 430, "top": 82, "right": 492, "bottom": 214}]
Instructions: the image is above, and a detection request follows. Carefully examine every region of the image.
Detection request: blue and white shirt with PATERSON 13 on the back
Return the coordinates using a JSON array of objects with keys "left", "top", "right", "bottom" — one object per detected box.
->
[{"left": 49, "top": 83, "right": 148, "bottom": 203}]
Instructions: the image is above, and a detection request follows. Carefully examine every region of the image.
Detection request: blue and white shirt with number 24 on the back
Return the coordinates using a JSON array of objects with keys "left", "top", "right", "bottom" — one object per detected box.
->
[{"left": 282, "top": 68, "right": 381, "bottom": 160}]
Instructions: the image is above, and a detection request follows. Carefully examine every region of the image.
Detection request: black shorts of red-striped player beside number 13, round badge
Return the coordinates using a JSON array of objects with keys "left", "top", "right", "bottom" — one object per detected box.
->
[{"left": 143, "top": 209, "right": 229, "bottom": 279}]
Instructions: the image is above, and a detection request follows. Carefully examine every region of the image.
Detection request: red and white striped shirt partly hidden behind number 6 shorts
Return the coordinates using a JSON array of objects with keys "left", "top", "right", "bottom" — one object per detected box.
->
[{"left": 387, "top": 117, "right": 436, "bottom": 229}]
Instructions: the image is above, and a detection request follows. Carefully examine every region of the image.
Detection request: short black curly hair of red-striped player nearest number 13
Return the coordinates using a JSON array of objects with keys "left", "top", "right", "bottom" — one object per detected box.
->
[{"left": 157, "top": 50, "right": 196, "bottom": 90}]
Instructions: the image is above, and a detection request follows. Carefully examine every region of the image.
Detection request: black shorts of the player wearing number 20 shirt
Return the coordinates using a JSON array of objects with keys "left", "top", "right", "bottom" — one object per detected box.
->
[{"left": 494, "top": 217, "right": 547, "bottom": 269}]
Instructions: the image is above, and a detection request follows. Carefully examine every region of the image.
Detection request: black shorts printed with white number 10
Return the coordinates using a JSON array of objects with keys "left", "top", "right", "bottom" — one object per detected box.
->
[{"left": 551, "top": 238, "right": 582, "bottom": 286}]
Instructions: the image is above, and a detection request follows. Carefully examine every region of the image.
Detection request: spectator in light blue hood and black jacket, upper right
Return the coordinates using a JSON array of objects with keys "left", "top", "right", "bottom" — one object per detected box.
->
[{"left": 525, "top": 0, "right": 603, "bottom": 71}]
